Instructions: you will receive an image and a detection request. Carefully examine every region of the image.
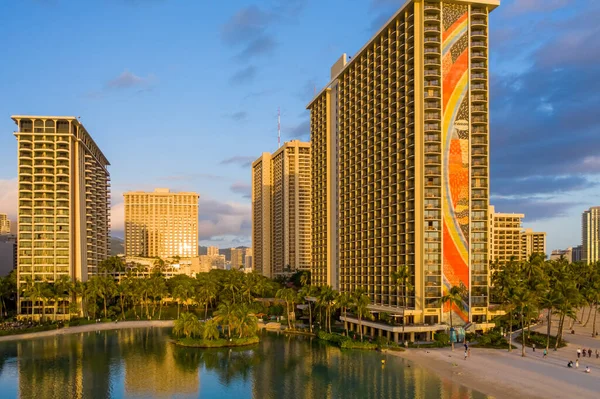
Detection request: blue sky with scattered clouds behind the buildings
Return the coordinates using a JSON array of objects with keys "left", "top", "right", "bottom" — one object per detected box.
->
[{"left": 0, "top": 0, "right": 600, "bottom": 250}]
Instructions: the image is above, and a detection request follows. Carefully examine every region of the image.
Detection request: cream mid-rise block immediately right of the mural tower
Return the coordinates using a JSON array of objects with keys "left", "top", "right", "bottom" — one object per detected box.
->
[{"left": 489, "top": 206, "right": 525, "bottom": 264}]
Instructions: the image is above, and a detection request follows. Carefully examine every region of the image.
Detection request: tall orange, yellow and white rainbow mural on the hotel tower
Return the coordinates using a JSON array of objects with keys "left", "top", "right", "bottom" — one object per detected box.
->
[{"left": 442, "top": 3, "right": 470, "bottom": 322}]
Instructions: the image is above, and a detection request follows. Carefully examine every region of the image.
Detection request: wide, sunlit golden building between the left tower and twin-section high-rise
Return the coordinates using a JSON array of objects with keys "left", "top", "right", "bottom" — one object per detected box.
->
[{"left": 124, "top": 188, "right": 199, "bottom": 258}]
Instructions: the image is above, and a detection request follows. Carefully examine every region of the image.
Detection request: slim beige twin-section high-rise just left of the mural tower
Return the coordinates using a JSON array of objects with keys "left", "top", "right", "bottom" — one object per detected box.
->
[{"left": 252, "top": 140, "right": 311, "bottom": 277}]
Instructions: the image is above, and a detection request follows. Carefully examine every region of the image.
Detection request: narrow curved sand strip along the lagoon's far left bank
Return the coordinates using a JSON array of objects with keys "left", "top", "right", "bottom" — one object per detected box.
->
[{"left": 0, "top": 320, "right": 175, "bottom": 342}]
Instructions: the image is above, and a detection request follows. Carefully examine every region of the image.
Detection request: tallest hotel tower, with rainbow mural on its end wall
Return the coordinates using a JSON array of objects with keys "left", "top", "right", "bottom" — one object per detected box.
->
[{"left": 308, "top": 0, "right": 500, "bottom": 324}]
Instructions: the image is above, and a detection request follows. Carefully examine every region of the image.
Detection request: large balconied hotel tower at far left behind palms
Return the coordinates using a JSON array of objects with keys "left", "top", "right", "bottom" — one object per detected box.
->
[{"left": 12, "top": 115, "right": 110, "bottom": 317}]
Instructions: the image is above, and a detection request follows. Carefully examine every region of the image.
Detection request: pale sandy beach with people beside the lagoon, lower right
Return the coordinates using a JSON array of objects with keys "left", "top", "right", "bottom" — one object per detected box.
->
[{"left": 387, "top": 312, "right": 600, "bottom": 399}]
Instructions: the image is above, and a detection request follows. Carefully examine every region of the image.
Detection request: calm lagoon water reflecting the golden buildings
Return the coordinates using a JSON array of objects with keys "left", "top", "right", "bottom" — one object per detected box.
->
[{"left": 0, "top": 328, "right": 485, "bottom": 399}]
